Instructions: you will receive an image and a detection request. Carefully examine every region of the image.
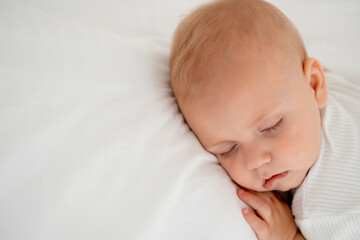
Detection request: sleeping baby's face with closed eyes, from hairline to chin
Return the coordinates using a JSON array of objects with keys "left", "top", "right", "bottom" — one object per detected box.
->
[{"left": 179, "top": 50, "right": 321, "bottom": 191}]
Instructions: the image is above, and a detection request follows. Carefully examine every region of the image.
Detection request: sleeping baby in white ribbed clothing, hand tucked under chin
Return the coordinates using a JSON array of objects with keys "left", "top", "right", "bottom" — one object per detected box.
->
[{"left": 170, "top": 0, "right": 360, "bottom": 240}]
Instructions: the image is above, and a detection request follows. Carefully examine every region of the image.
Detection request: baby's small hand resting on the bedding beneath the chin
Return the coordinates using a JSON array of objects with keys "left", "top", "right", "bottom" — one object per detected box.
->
[{"left": 237, "top": 189, "right": 297, "bottom": 240}]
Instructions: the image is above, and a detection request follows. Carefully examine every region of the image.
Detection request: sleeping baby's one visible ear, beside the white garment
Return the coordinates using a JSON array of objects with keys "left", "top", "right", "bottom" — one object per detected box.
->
[{"left": 304, "top": 58, "right": 328, "bottom": 109}]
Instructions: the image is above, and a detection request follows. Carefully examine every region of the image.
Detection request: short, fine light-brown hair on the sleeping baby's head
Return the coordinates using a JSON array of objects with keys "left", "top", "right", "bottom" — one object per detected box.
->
[{"left": 170, "top": 0, "right": 307, "bottom": 102}]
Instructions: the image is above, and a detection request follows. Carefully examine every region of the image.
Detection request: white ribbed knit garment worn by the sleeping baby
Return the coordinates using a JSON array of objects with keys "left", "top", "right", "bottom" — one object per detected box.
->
[{"left": 292, "top": 73, "right": 360, "bottom": 240}]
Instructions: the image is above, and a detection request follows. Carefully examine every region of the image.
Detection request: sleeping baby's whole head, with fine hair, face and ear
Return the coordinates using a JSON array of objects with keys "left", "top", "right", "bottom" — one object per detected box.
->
[{"left": 170, "top": 0, "right": 327, "bottom": 191}]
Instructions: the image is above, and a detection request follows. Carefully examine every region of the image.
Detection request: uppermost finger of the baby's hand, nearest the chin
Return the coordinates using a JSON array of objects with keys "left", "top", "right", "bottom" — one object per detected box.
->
[{"left": 237, "top": 189, "right": 271, "bottom": 222}]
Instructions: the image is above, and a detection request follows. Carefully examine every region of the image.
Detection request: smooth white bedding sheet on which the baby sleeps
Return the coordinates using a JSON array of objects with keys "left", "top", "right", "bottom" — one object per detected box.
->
[{"left": 0, "top": 0, "right": 360, "bottom": 240}]
